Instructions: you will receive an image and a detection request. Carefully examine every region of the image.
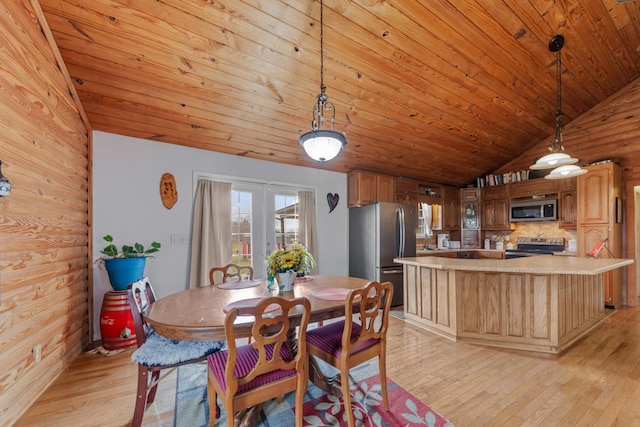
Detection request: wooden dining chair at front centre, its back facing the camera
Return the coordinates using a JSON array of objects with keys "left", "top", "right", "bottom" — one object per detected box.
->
[{"left": 207, "top": 297, "right": 311, "bottom": 427}]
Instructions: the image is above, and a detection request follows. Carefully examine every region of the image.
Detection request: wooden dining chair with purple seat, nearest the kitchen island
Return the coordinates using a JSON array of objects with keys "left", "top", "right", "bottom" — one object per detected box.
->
[{"left": 307, "top": 281, "right": 393, "bottom": 427}]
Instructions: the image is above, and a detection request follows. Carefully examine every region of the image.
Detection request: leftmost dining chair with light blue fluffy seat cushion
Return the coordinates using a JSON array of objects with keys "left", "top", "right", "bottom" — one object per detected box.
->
[{"left": 127, "top": 277, "right": 226, "bottom": 427}]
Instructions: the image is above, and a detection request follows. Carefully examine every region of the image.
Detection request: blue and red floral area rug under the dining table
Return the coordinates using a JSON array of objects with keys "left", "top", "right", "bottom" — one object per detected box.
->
[{"left": 174, "top": 362, "right": 453, "bottom": 427}]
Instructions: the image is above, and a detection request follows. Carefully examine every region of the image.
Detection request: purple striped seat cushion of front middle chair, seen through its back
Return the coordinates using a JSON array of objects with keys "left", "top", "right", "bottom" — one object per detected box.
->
[{"left": 207, "top": 345, "right": 297, "bottom": 393}]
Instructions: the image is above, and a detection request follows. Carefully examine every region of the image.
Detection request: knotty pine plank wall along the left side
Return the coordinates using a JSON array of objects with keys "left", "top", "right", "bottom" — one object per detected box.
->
[{"left": 0, "top": 0, "right": 90, "bottom": 426}]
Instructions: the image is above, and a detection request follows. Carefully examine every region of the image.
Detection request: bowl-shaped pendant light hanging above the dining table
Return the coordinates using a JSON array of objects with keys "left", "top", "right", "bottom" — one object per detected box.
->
[{"left": 300, "top": 0, "right": 347, "bottom": 163}]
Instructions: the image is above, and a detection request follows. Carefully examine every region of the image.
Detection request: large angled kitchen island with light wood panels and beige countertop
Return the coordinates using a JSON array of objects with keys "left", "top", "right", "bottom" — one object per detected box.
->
[{"left": 395, "top": 255, "right": 633, "bottom": 354}]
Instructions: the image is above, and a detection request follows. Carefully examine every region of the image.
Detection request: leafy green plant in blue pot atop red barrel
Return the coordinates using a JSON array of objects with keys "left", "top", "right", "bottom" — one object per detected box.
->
[{"left": 100, "top": 234, "right": 161, "bottom": 291}]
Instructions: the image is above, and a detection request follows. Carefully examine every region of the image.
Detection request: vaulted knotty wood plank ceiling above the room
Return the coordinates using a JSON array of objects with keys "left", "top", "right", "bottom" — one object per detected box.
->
[{"left": 40, "top": 0, "right": 640, "bottom": 185}]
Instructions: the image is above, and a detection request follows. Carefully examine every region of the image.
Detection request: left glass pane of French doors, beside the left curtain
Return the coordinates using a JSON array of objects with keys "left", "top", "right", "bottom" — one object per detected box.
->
[{"left": 231, "top": 191, "right": 253, "bottom": 265}]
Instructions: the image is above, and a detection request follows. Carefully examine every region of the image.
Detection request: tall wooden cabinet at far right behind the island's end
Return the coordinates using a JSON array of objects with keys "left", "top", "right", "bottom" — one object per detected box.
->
[{"left": 577, "top": 163, "right": 622, "bottom": 308}]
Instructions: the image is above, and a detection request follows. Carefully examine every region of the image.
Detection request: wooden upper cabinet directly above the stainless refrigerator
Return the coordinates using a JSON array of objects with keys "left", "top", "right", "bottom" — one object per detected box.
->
[{"left": 347, "top": 170, "right": 395, "bottom": 208}]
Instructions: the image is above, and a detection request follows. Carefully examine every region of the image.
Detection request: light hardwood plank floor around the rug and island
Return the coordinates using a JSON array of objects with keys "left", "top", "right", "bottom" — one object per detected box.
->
[{"left": 16, "top": 308, "right": 640, "bottom": 427}]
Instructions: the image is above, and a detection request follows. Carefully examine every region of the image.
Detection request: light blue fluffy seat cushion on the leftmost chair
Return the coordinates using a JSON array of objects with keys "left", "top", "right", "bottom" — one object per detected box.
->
[{"left": 131, "top": 332, "right": 226, "bottom": 367}]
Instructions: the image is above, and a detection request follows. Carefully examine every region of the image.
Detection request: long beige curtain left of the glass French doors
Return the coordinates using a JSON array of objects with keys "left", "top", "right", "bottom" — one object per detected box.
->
[{"left": 189, "top": 179, "right": 232, "bottom": 288}]
